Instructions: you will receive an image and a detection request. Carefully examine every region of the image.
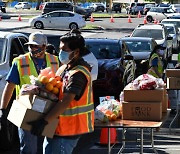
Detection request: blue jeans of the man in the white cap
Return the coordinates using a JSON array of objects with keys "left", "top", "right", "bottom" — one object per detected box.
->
[{"left": 18, "top": 128, "right": 37, "bottom": 154}]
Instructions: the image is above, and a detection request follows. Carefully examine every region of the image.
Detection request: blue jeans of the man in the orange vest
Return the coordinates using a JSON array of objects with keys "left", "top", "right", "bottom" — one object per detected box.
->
[{"left": 43, "top": 136, "right": 80, "bottom": 154}]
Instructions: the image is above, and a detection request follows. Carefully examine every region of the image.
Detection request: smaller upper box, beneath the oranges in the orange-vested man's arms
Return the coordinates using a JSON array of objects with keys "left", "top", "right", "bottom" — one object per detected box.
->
[{"left": 18, "top": 95, "right": 56, "bottom": 113}]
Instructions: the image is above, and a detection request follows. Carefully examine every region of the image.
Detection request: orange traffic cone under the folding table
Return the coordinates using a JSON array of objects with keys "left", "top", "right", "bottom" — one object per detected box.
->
[{"left": 100, "top": 128, "right": 117, "bottom": 144}]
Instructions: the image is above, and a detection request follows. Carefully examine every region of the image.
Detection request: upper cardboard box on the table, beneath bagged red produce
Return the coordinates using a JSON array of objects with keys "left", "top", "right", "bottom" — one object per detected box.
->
[{"left": 124, "top": 88, "right": 164, "bottom": 102}]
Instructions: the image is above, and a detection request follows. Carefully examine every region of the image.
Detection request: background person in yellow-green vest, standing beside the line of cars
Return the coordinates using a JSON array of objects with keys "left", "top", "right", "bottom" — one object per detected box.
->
[{"left": 147, "top": 45, "right": 165, "bottom": 78}]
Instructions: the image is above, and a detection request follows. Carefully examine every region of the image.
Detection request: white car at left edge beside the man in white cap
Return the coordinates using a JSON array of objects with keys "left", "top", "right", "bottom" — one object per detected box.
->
[{"left": 0, "top": 32, "right": 28, "bottom": 98}]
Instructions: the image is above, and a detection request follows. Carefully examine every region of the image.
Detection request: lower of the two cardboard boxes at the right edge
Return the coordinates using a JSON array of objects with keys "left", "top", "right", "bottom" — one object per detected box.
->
[{"left": 166, "top": 77, "right": 180, "bottom": 90}]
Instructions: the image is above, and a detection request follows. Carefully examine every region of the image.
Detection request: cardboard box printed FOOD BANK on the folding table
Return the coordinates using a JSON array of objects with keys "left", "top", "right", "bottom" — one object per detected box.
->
[{"left": 122, "top": 102, "right": 162, "bottom": 121}]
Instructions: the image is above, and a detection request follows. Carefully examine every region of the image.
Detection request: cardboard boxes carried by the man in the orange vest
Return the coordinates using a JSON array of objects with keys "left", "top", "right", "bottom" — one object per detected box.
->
[{"left": 8, "top": 95, "right": 58, "bottom": 138}]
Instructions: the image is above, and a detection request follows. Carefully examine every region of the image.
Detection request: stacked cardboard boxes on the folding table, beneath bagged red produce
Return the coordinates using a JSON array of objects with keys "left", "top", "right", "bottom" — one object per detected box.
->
[{"left": 122, "top": 86, "right": 168, "bottom": 121}]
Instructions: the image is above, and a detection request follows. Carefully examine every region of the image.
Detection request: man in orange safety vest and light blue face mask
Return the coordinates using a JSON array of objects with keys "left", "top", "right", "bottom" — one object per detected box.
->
[{"left": 27, "top": 30, "right": 94, "bottom": 154}]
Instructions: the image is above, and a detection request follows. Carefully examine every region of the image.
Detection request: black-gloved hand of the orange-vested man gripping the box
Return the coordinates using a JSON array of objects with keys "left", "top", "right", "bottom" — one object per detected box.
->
[{"left": 28, "top": 118, "right": 48, "bottom": 136}]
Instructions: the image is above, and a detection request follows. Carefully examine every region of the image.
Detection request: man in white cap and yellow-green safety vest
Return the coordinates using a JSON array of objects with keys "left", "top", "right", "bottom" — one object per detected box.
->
[{"left": 0, "top": 32, "right": 59, "bottom": 154}]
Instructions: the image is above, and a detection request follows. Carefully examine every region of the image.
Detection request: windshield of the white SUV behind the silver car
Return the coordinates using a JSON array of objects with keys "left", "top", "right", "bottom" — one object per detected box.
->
[{"left": 133, "top": 29, "right": 163, "bottom": 40}]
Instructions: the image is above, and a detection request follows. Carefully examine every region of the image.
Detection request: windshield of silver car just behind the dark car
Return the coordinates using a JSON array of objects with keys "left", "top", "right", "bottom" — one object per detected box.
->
[{"left": 125, "top": 41, "right": 152, "bottom": 52}]
